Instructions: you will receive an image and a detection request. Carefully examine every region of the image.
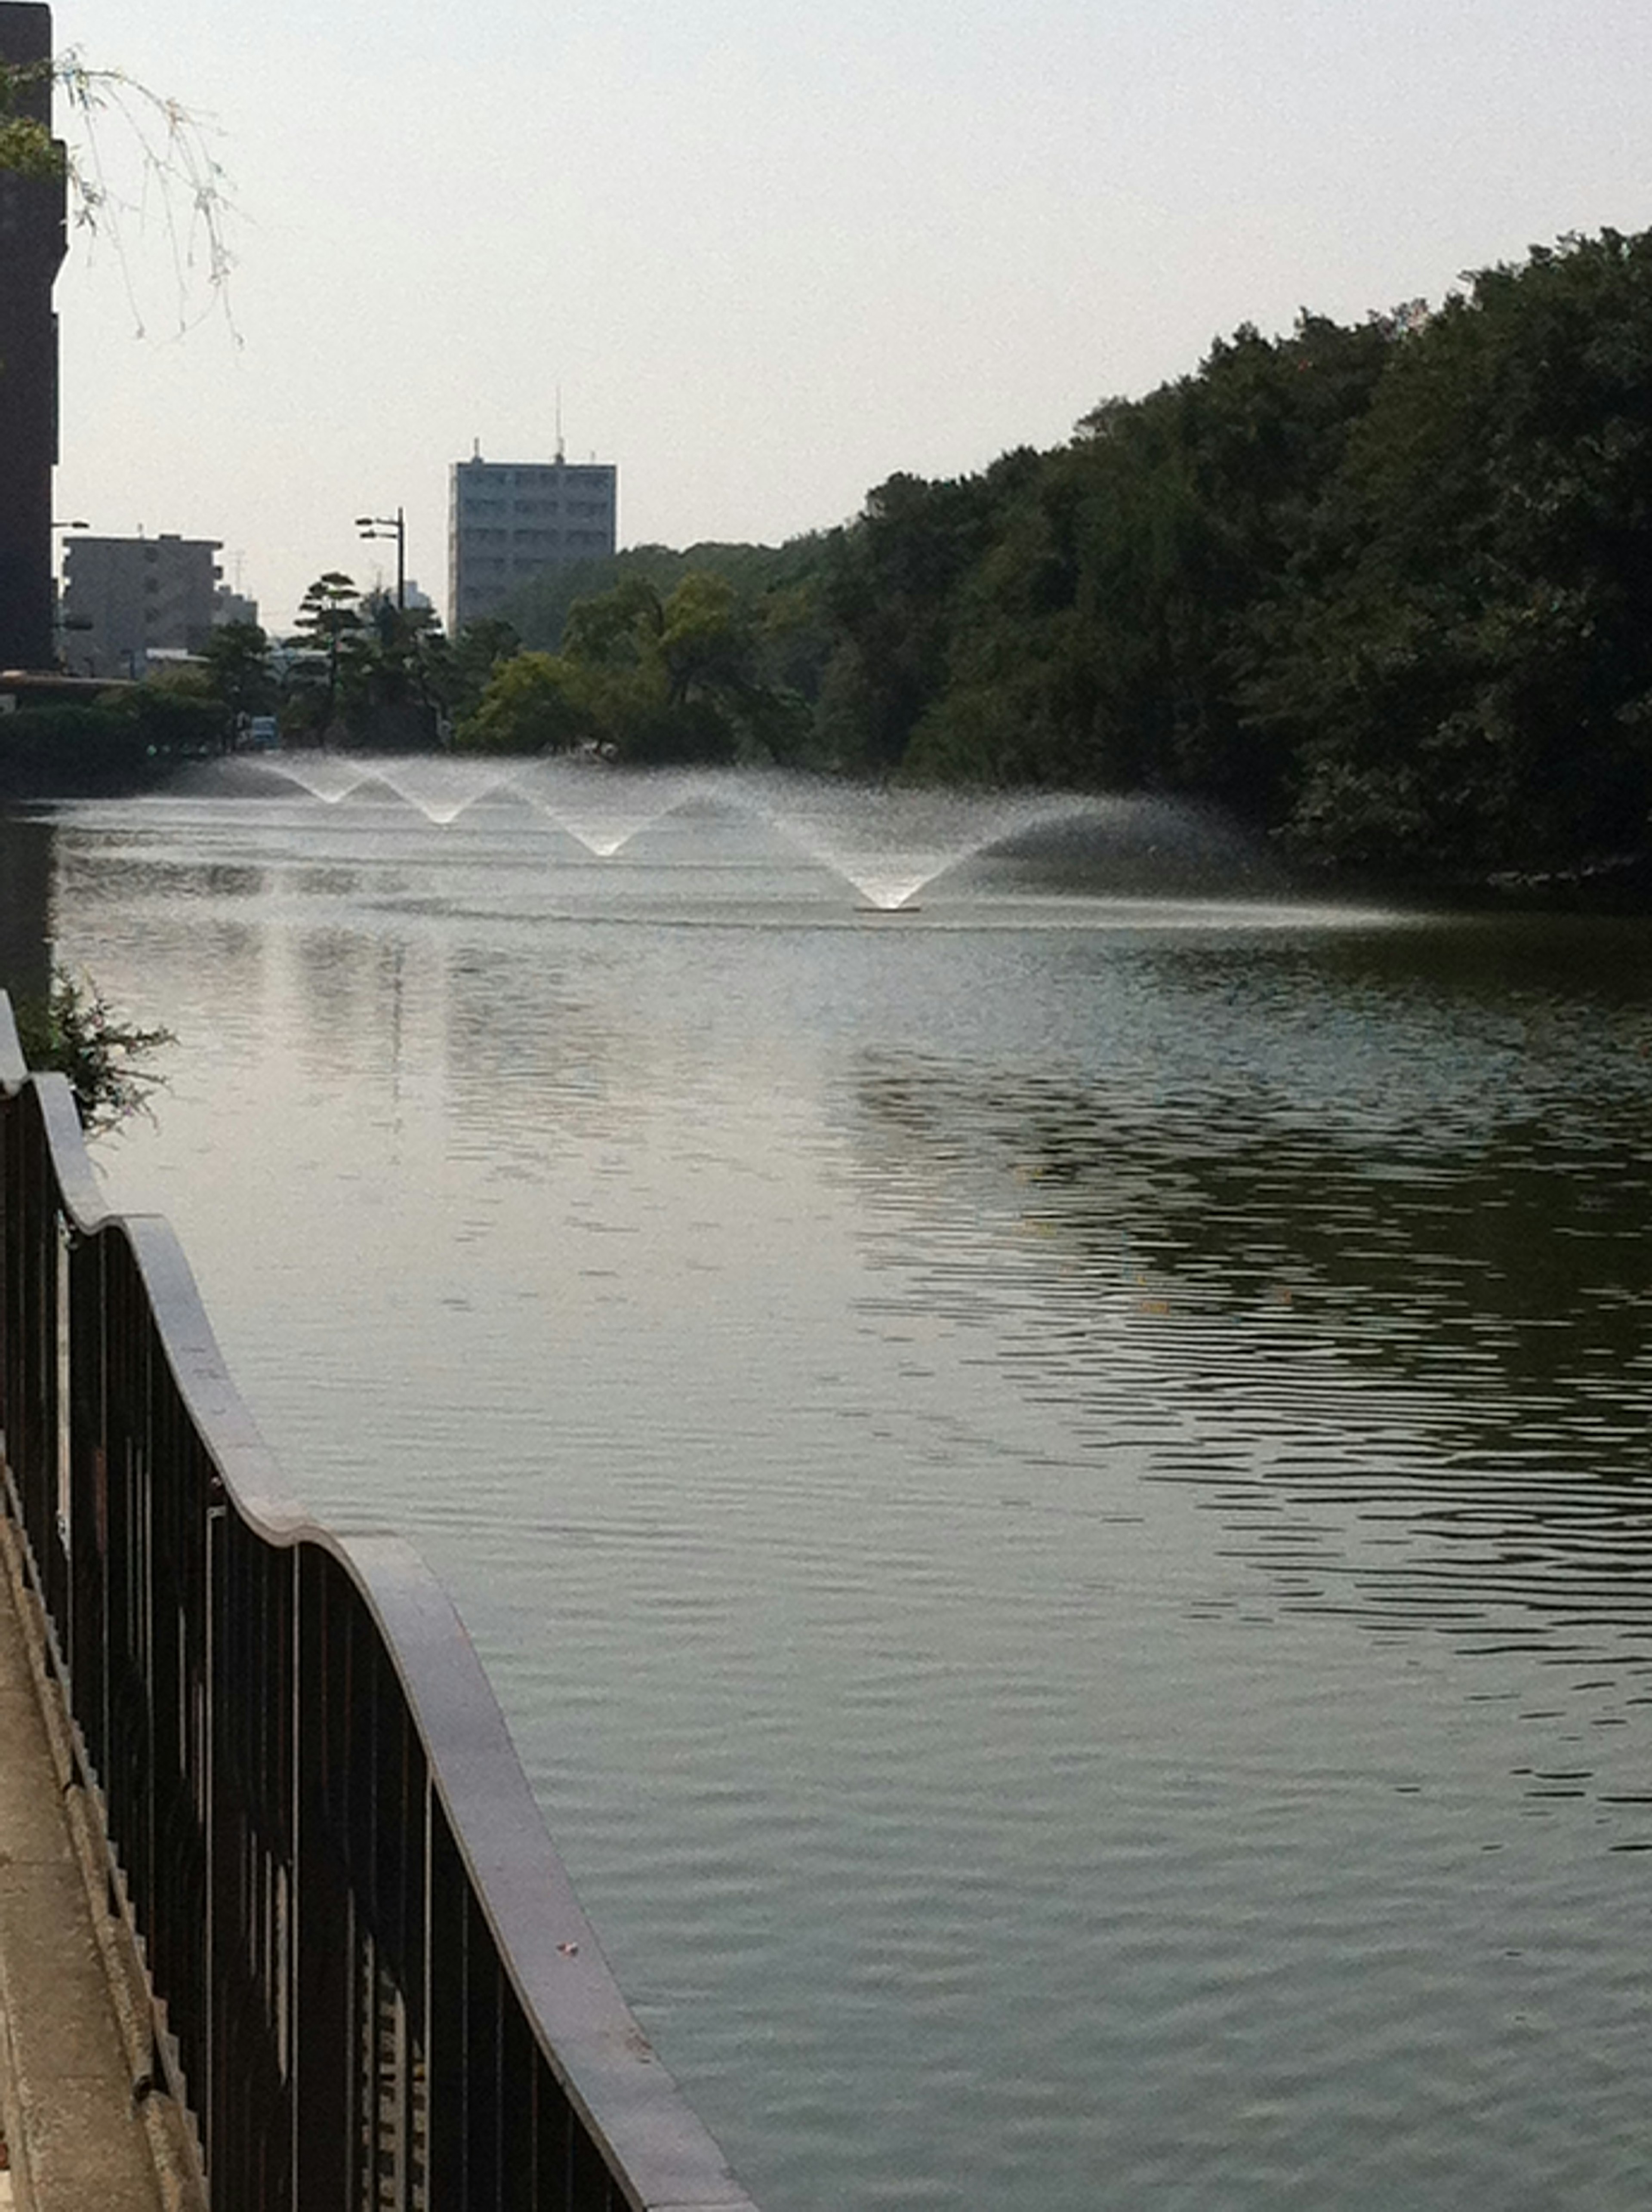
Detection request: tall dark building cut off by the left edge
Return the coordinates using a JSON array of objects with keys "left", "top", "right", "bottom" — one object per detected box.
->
[{"left": 0, "top": 0, "right": 66, "bottom": 668}]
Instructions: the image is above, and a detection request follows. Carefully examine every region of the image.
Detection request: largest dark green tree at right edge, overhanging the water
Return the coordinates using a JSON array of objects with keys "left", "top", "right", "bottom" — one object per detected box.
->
[{"left": 1245, "top": 230, "right": 1652, "bottom": 869}]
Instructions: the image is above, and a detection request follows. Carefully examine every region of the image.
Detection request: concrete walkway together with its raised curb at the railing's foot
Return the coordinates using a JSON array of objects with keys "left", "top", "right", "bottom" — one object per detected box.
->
[{"left": 0, "top": 1513, "right": 208, "bottom": 2212}]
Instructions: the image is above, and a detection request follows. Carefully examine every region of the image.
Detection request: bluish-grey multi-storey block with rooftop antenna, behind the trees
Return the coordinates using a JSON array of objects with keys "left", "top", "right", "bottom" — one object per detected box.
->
[{"left": 447, "top": 451, "right": 619, "bottom": 630}]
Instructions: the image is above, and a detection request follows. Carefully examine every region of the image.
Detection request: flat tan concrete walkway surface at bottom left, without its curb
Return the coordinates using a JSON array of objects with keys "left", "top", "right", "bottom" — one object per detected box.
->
[{"left": 0, "top": 1526, "right": 179, "bottom": 2212}]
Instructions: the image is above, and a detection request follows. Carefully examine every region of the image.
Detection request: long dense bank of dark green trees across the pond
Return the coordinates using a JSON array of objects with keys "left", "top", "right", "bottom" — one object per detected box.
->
[{"left": 469, "top": 232, "right": 1652, "bottom": 872}]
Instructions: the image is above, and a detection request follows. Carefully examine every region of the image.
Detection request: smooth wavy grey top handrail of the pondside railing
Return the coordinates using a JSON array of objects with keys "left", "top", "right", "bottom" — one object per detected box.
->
[{"left": 0, "top": 991, "right": 754, "bottom": 2212}]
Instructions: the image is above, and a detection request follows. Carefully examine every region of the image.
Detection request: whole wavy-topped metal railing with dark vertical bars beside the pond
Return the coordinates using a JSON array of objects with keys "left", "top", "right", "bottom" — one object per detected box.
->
[{"left": 0, "top": 993, "right": 754, "bottom": 2212}]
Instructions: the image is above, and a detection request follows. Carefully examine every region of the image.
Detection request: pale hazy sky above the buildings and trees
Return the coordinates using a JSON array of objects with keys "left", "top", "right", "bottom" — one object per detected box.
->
[{"left": 55, "top": 0, "right": 1652, "bottom": 628}]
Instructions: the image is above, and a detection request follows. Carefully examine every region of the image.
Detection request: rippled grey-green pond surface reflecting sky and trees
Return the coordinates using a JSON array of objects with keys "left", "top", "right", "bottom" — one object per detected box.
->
[{"left": 26, "top": 792, "right": 1652, "bottom": 2212}]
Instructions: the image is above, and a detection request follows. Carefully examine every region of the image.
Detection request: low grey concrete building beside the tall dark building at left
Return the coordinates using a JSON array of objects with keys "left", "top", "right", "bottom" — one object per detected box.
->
[{"left": 62, "top": 535, "right": 223, "bottom": 677}]
